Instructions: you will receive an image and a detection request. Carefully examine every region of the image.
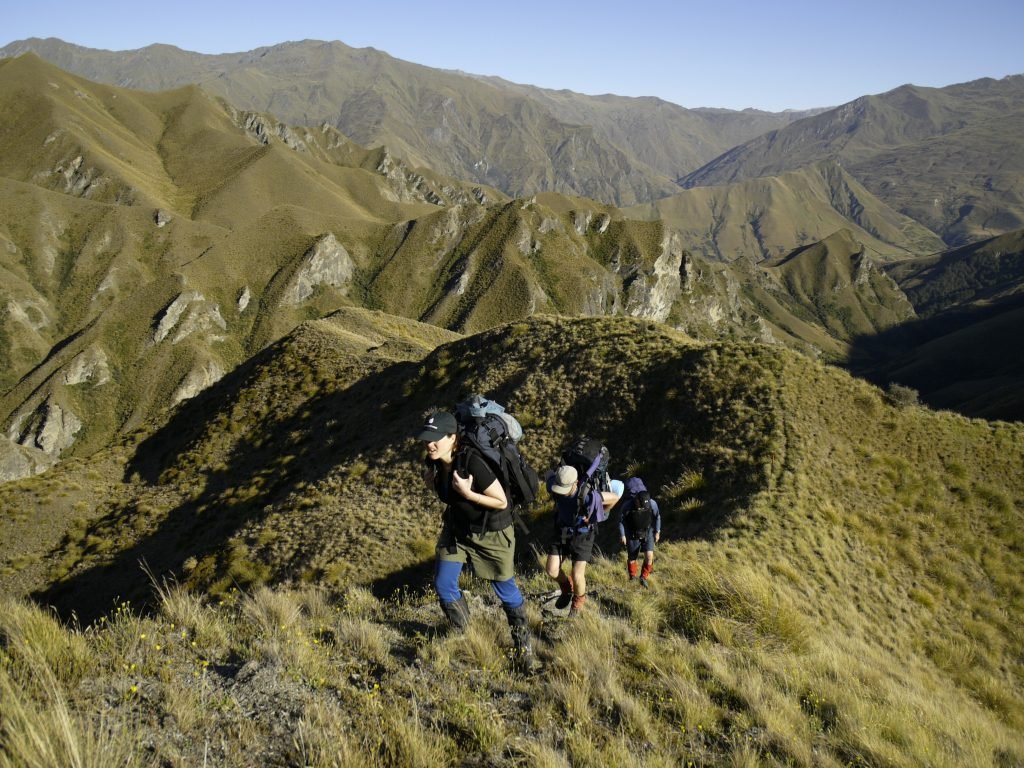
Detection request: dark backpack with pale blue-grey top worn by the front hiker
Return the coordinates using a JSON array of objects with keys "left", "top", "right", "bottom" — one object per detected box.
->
[{"left": 455, "top": 394, "right": 540, "bottom": 509}]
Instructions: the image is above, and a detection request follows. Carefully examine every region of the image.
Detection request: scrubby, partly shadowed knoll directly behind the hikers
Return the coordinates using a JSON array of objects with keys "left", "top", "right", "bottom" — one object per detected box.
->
[{"left": 34, "top": 317, "right": 784, "bottom": 620}]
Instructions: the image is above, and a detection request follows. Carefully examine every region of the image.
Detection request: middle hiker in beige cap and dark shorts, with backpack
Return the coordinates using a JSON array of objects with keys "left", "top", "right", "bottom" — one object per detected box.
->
[{"left": 546, "top": 438, "right": 618, "bottom": 616}]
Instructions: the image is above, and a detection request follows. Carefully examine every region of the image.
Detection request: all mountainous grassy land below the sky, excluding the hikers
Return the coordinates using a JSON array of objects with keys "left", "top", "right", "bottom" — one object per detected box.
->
[{"left": 0, "top": 40, "right": 1024, "bottom": 768}]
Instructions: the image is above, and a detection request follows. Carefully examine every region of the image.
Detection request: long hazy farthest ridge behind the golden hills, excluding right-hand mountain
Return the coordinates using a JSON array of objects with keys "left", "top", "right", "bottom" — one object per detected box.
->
[{"left": 0, "top": 39, "right": 815, "bottom": 205}]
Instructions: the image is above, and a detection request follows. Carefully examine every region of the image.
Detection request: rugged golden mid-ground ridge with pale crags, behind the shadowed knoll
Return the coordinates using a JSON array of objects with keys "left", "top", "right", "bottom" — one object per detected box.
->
[{"left": 0, "top": 54, "right": 946, "bottom": 479}]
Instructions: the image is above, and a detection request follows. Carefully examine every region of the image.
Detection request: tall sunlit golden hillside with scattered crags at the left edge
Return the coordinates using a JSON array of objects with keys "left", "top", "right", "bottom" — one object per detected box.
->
[{"left": 0, "top": 55, "right": 491, "bottom": 468}]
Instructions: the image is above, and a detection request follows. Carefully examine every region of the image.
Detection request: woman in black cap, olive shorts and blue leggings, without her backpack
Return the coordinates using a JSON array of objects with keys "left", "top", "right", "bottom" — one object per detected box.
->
[{"left": 417, "top": 411, "right": 537, "bottom": 672}]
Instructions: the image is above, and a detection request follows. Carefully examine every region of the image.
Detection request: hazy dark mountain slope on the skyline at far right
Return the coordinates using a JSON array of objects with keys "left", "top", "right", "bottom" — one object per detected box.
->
[{"left": 681, "top": 76, "right": 1024, "bottom": 245}]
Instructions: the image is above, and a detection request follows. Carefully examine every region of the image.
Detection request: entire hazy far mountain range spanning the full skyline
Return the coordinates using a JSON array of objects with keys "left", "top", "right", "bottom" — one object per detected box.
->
[{"left": 8, "top": 39, "right": 1024, "bottom": 246}]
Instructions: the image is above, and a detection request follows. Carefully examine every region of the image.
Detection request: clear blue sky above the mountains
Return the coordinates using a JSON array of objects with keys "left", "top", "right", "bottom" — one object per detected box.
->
[{"left": 0, "top": 0, "right": 1024, "bottom": 112}]
